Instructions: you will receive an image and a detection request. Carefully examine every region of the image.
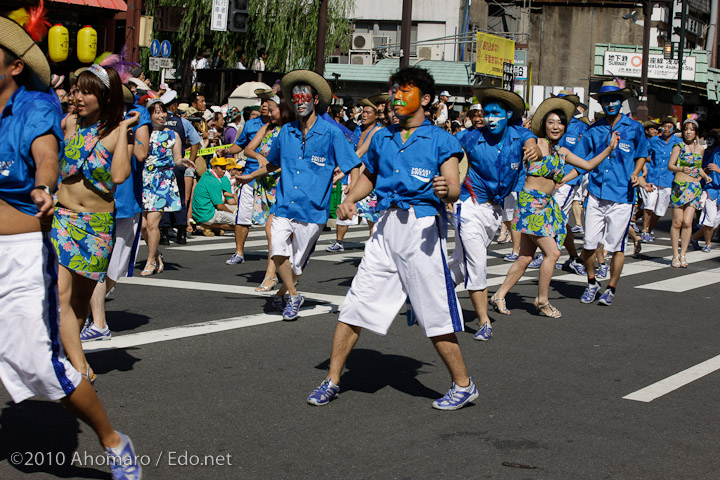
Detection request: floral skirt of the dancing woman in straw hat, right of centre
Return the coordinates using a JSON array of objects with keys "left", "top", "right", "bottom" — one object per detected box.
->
[{"left": 512, "top": 190, "right": 567, "bottom": 248}]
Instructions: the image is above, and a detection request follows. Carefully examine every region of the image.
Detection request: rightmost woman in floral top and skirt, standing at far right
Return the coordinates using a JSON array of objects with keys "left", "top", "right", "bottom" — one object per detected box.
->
[{"left": 668, "top": 119, "right": 712, "bottom": 268}]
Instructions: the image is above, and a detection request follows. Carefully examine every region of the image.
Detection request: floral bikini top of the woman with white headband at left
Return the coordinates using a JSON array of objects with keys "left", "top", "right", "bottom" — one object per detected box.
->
[{"left": 60, "top": 122, "right": 115, "bottom": 193}]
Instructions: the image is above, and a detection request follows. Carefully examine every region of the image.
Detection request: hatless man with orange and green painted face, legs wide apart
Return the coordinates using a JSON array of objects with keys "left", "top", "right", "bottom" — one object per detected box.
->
[{"left": 308, "top": 67, "right": 479, "bottom": 410}]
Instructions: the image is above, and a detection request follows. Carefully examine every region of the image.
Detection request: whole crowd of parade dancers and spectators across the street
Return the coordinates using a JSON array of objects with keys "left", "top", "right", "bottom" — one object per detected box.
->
[{"left": 0, "top": 4, "right": 720, "bottom": 478}]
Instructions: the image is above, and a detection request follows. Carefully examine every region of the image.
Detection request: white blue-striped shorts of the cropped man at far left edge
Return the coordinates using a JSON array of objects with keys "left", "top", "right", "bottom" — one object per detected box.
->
[{"left": 0, "top": 232, "right": 82, "bottom": 403}]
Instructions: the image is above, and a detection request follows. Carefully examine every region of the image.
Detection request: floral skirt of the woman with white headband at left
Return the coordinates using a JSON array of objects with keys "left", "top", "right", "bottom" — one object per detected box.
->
[{"left": 50, "top": 206, "right": 115, "bottom": 282}]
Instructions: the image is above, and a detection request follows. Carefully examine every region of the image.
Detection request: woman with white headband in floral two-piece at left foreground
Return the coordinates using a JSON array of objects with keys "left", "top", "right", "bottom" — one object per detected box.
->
[{"left": 52, "top": 58, "right": 140, "bottom": 381}]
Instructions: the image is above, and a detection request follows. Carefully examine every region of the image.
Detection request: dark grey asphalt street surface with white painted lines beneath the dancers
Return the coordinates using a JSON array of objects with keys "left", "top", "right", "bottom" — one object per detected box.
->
[{"left": 0, "top": 219, "right": 720, "bottom": 480}]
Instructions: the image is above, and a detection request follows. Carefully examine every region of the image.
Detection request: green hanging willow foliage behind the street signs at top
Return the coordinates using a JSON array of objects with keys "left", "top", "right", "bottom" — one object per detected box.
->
[{"left": 141, "top": 0, "right": 355, "bottom": 85}]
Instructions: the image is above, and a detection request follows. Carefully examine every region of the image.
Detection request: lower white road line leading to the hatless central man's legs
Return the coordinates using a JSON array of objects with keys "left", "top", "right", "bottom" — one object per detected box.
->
[{"left": 83, "top": 305, "right": 337, "bottom": 353}]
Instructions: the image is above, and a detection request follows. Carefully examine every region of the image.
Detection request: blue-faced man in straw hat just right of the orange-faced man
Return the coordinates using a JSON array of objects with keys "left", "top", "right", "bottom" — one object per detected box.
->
[{"left": 451, "top": 88, "right": 541, "bottom": 341}]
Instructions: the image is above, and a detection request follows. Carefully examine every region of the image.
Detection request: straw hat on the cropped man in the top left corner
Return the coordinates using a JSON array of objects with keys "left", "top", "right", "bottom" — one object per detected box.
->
[{"left": 0, "top": 17, "right": 50, "bottom": 91}]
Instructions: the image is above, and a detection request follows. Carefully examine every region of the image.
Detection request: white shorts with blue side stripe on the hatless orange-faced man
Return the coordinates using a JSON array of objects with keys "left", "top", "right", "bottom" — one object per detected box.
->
[{"left": 338, "top": 208, "right": 464, "bottom": 337}]
